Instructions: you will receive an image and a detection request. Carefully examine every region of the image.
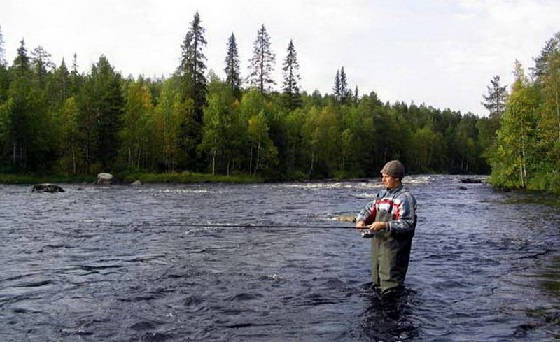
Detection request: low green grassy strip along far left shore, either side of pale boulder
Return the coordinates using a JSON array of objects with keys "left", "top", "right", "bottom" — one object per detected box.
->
[{"left": 0, "top": 171, "right": 265, "bottom": 184}]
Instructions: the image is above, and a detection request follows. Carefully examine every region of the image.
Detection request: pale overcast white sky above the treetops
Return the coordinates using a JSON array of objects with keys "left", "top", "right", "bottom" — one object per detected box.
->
[{"left": 0, "top": 0, "right": 560, "bottom": 116}]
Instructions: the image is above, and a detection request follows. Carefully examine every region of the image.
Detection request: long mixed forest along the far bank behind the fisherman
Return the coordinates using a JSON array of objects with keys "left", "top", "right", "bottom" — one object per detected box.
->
[{"left": 0, "top": 13, "right": 496, "bottom": 179}]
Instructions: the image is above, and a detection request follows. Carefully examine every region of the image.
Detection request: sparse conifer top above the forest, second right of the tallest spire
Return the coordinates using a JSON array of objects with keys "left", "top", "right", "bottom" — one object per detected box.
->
[{"left": 249, "top": 24, "right": 276, "bottom": 94}]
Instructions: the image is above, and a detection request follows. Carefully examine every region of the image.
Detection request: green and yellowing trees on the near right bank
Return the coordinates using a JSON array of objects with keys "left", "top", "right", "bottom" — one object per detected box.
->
[{"left": 488, "top": 32, "right": 560, "bottom": 193}]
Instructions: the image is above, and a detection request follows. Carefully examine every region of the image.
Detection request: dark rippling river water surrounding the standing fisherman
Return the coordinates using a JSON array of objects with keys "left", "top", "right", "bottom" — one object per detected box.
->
[{"left": 0, "top": 176, "right": 560, "bottom": 341}]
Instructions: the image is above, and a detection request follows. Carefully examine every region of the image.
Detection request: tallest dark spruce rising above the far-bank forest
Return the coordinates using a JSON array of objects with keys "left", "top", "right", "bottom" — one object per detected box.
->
[{"left": 179, "top": 12, "right": 206, "bottom": 124}]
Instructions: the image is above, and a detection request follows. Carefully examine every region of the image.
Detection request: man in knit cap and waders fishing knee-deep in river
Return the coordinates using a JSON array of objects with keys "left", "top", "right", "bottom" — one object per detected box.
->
[{"left": 356, "top": 160, "right": 416, "bottom": 293}]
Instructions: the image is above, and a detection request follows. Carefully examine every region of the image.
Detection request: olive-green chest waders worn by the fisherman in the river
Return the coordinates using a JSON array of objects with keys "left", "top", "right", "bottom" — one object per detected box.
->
[{"left": 371, "top": 197, "right": 412, "bottom": 291}]
